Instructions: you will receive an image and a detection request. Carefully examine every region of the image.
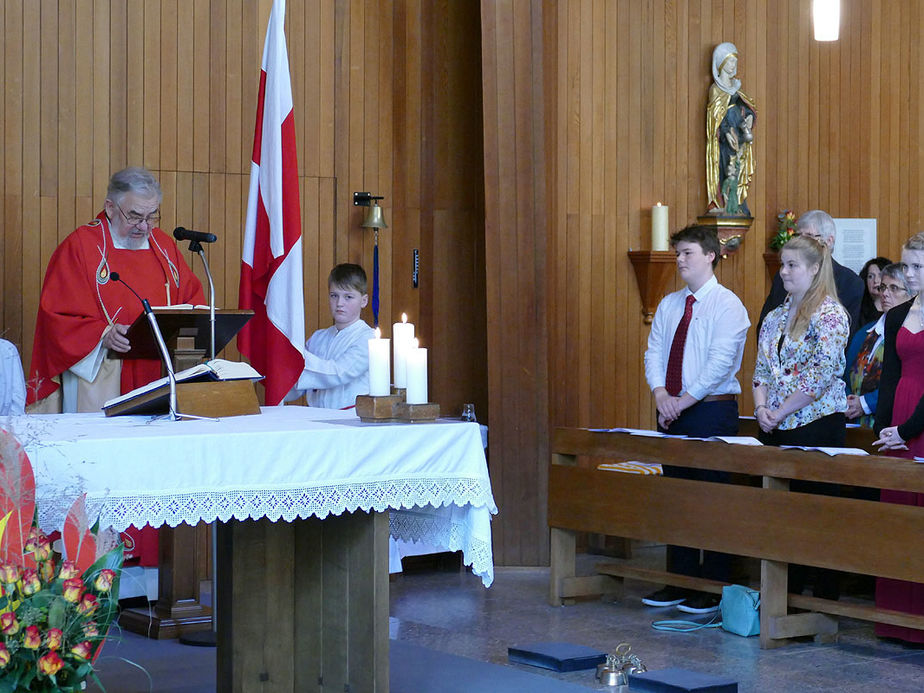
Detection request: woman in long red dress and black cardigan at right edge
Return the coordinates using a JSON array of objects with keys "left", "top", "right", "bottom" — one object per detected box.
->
[{"left": 874, "top": 233, "right": 924, "bottom": 643}]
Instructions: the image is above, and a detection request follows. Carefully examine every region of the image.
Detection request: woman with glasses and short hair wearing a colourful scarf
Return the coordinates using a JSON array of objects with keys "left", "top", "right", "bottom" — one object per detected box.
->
[{"left": 844, "top": 263, "right": 911, "bottom": 428}]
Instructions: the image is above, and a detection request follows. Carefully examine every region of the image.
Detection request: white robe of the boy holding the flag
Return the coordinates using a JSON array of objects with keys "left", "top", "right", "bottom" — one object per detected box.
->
[{"left": 286, "top": 320, "right": 375, "bottom": 409}]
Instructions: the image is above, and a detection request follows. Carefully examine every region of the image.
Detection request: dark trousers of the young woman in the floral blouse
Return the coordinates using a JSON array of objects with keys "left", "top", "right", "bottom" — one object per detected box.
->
[{"left": 759, "top": 414, "right": 847, "bottom": 599}]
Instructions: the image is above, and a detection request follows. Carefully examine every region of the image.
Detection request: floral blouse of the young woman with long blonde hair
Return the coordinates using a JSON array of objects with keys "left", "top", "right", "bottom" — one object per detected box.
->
[{"left": 754, "top": 296, "right": 850, "bottom": 430}]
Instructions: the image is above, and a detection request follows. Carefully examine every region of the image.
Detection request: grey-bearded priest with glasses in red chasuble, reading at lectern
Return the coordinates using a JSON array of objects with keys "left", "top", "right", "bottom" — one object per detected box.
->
[{"left": 27, "top": 168, "right": 205, "bottom": 413}]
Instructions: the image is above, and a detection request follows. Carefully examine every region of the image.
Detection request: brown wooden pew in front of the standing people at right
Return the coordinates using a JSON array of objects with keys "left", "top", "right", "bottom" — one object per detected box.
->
[{"left": 548, "top": 428, "right": 924, "bottom": 648}]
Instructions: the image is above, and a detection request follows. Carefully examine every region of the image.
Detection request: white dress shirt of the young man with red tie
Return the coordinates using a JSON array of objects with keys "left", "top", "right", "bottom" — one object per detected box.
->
[{"left": 645, "top": 276, "right": 751, "bottom": 400}]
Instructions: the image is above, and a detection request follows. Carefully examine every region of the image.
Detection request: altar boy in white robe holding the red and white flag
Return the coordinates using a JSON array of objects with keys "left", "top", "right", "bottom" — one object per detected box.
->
[{"left": 286, "top": 263, "right": 375, "bottom": 409}]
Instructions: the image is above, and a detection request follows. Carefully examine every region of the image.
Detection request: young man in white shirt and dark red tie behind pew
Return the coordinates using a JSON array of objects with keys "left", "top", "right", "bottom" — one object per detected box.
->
[{"left": 642, "top": 225, "right": 751, "bottom": 614}]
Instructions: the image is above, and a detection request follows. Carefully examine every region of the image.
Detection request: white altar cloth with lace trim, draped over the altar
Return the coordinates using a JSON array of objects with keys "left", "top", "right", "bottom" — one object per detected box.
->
[{"left": 2, "top": 406, "right": 497, "bottom": 586}]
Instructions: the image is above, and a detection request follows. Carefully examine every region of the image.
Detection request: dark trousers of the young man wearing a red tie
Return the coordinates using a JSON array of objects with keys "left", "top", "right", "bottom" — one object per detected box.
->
[{"left": 658, "top": 400, "right": 738, "bottom": 582}]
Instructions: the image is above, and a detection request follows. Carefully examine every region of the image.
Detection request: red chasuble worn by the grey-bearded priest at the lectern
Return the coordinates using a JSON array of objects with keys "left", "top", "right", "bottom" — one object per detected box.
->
[{"left": 27, "top": 212, "right": 205, "bottom": 404}]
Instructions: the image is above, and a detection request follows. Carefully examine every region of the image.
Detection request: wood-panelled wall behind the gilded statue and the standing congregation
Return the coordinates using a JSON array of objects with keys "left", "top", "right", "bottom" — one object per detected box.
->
[{"left": 481, "top": 0, "right": 924, "bottom": 563}]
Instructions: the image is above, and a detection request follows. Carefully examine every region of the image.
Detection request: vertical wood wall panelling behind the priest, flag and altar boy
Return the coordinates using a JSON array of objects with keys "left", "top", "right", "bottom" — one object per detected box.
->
[{"left": 0, "top": 0, "right": 487, "bottom": 416}]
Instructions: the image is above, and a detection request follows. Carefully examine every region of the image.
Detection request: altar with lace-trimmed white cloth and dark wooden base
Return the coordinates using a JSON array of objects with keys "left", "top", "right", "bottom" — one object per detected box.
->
[{"left": 6, "top": 407, "right": 497, "bottom": 691}]
